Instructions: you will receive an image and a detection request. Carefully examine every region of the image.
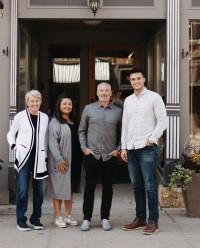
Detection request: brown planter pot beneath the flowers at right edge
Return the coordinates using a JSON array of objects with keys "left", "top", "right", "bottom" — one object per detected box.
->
[{"left": 183, "top": 173, "right": 200, "bottom": 218}]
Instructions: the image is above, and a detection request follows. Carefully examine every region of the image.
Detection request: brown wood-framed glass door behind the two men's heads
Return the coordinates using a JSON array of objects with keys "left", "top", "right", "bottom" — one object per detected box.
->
[{"left": 89, "top": 46, "right": 140, "bottom": 103}]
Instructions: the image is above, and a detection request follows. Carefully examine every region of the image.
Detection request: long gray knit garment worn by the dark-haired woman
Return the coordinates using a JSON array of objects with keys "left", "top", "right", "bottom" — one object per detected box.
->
[{"left": 48, "top": 118, "right": 71, "bottom": 200}]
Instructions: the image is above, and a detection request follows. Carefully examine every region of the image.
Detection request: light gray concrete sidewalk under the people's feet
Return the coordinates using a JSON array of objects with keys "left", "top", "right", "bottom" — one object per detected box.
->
[{"left": 0, "top": 185, "right": 200, "bottom": 248}]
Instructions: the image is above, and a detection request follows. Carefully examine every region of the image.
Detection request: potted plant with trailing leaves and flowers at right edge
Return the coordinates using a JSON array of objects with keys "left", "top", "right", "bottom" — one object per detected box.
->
[{"left": 168, "top": 138, "right": 200, "bottom": 217}]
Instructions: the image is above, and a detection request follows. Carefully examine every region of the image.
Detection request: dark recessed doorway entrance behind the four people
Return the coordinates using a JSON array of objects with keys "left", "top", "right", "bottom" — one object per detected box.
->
[{"left": 17, "top": 19, "right": 166, "bottom": 183}]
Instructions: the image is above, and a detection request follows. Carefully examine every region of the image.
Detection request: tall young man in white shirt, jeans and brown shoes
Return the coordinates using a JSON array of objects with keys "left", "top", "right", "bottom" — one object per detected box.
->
[{"left": 121, "top": 69, "right": 167, "bottom": 234}]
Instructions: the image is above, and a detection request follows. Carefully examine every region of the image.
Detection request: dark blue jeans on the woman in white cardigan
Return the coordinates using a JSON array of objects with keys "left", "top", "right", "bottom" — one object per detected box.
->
[{"left": 16, "top": 158, "right": 44, "bottom": 224}]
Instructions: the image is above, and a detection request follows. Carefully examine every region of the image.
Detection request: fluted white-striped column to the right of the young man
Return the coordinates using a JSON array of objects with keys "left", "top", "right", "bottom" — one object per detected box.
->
[{"left": 166, "top": 0, "right": 180, "bottom": 160}]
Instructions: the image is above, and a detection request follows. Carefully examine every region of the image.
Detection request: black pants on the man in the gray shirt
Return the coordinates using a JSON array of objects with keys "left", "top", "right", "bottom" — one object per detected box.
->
[{"left": 83, "top": 155, "right": 116, "bottom": 221}]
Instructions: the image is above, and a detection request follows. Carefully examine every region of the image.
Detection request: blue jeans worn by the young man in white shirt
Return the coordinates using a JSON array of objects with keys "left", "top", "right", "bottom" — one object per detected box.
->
[{"left": 128, "top": 145, "right": 159, "bottom": 223}]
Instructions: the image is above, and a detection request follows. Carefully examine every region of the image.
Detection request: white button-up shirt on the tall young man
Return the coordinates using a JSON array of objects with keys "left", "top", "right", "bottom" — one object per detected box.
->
[{"left": 121, "top": 88, "right": 167, "bottom": 150}]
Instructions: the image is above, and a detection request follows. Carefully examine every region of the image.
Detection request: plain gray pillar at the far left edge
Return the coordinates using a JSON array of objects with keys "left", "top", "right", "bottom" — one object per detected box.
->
[{"left": 0, "top": 0, "right": 11, "bottom": 204}]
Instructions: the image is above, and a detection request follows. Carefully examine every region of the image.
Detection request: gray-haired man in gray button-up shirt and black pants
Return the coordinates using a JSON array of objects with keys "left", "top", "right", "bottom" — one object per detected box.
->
[{"left": 79, "top": 82, "right": 122, "bottom": 231}]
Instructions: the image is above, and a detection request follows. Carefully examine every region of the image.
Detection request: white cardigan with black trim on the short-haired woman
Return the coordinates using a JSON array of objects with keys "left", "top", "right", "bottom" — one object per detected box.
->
[{"left": 7, "top": 110, "right": 48, "bottom": 179}]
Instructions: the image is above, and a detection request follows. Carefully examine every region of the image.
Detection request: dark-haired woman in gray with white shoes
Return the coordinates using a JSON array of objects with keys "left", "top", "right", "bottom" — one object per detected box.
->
[{"left": 49, "top": 95, "right": 79, "bottom": 227}]
